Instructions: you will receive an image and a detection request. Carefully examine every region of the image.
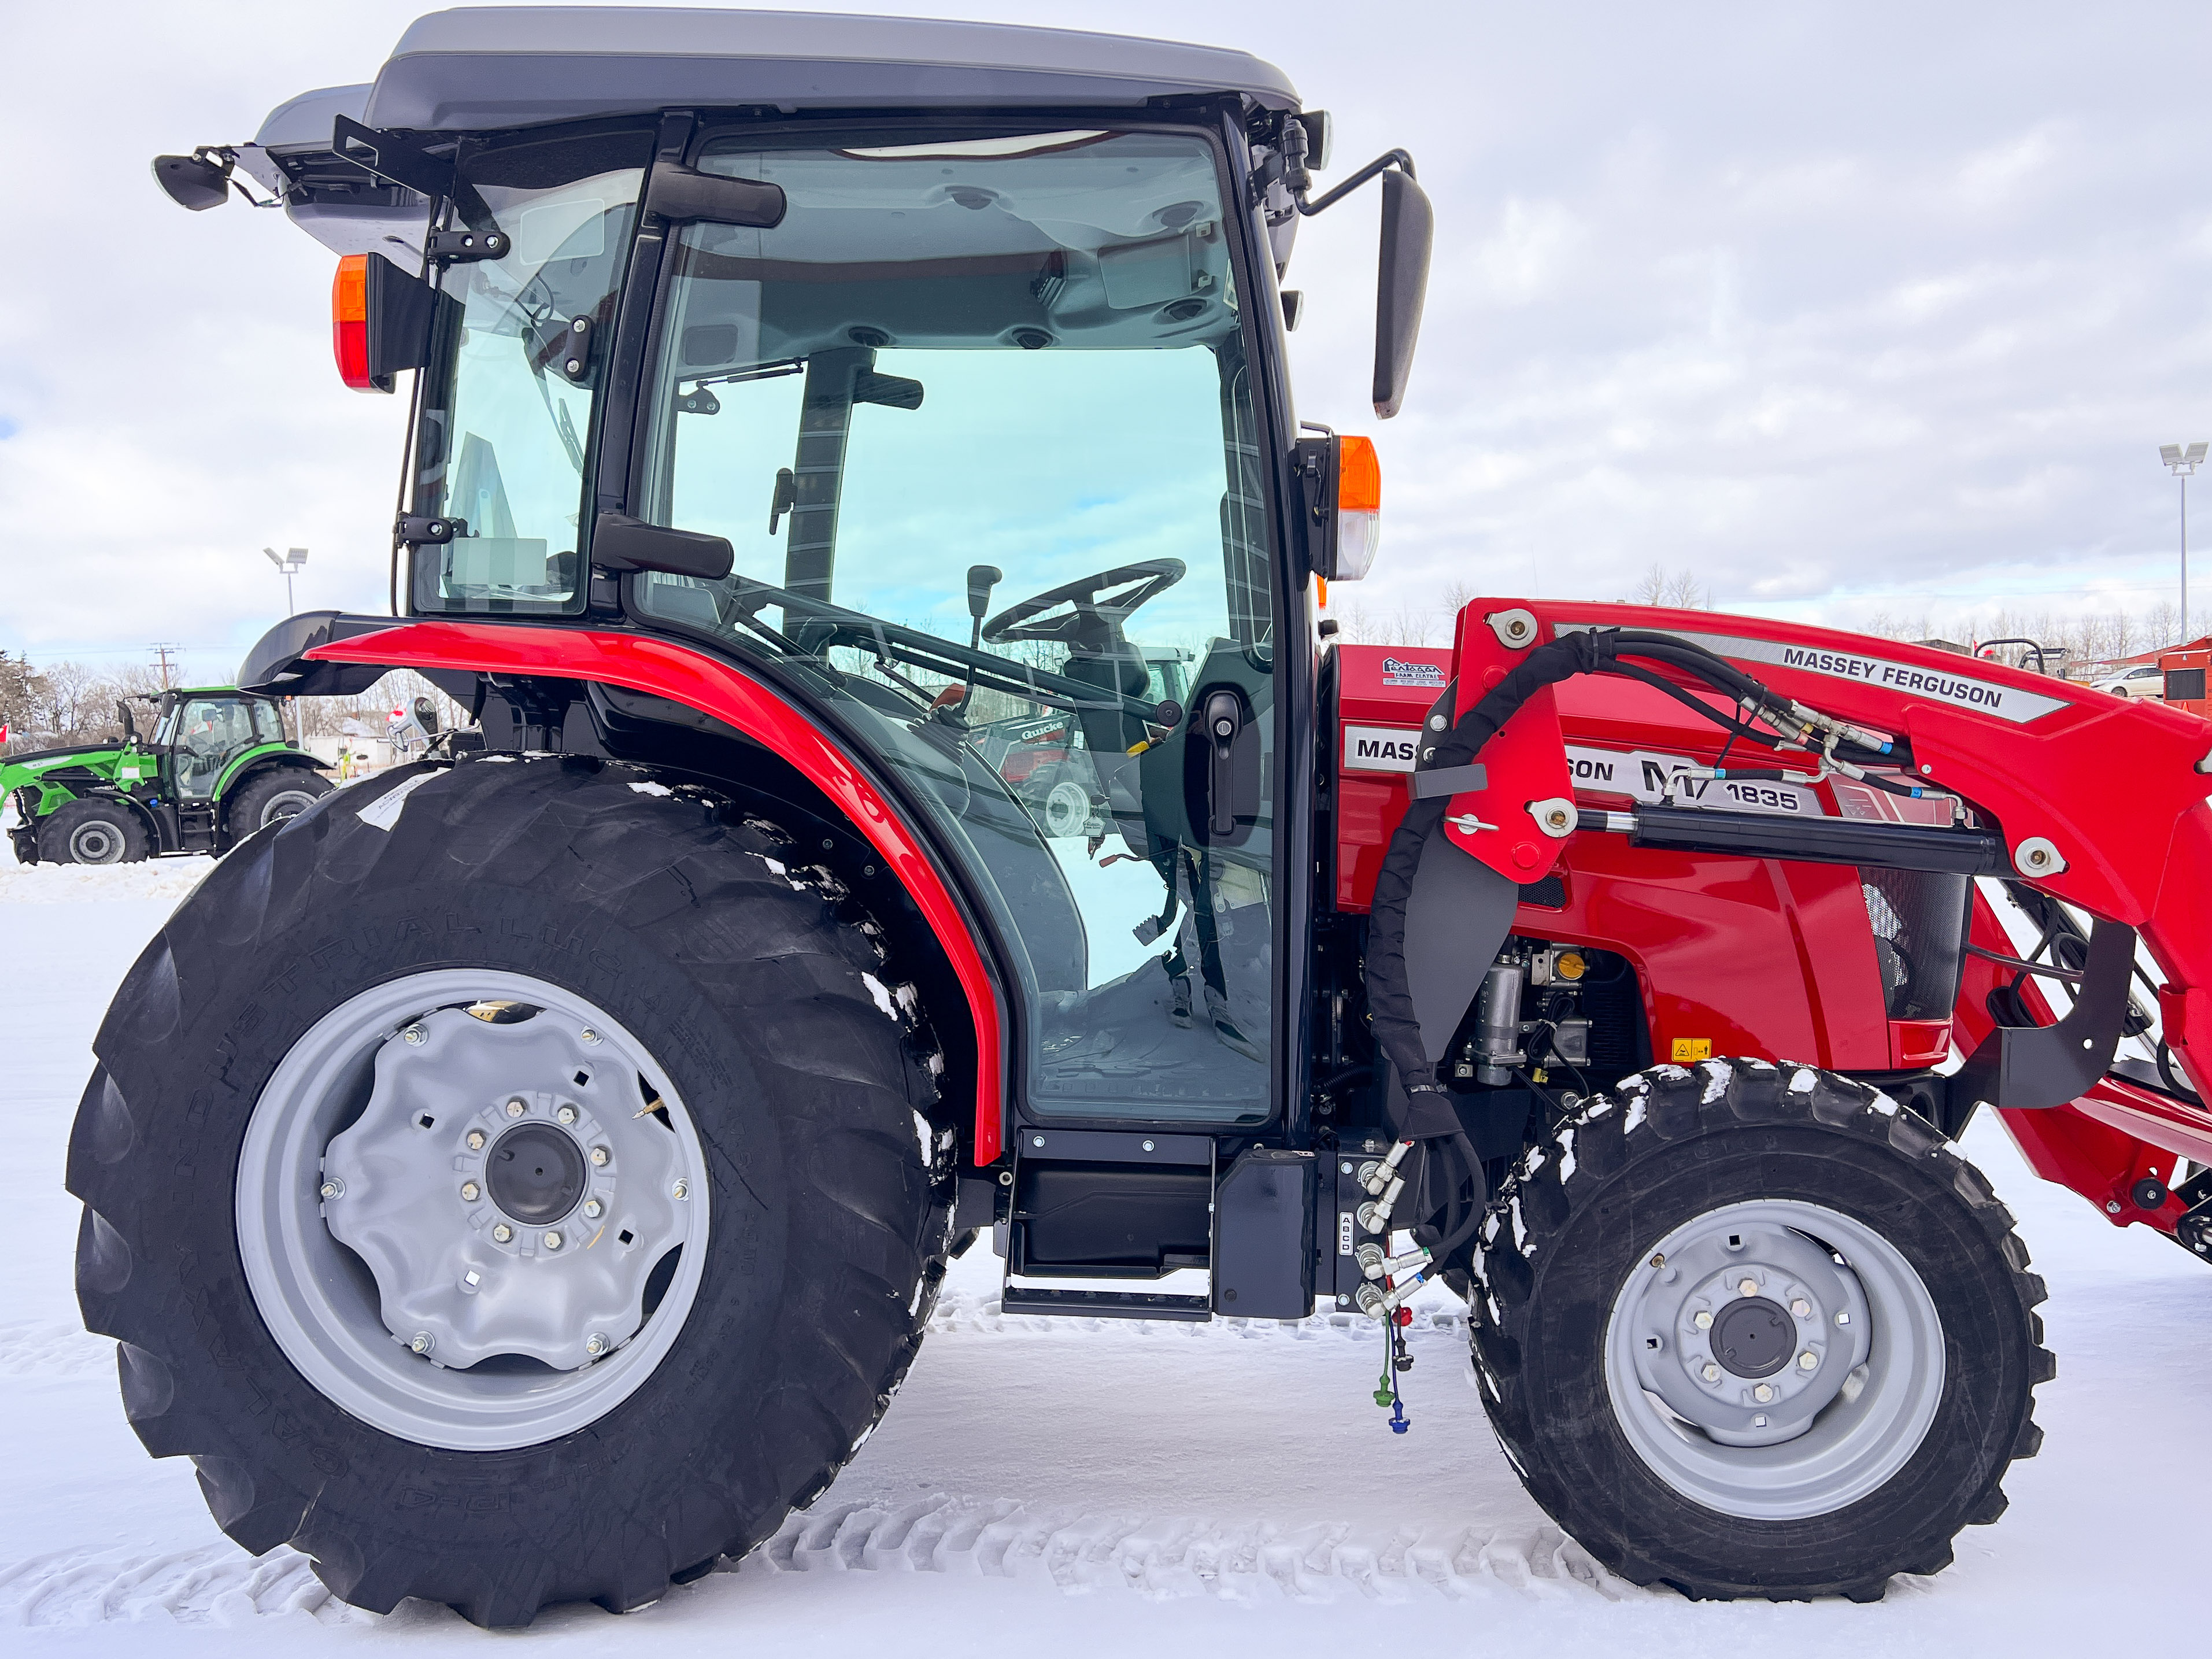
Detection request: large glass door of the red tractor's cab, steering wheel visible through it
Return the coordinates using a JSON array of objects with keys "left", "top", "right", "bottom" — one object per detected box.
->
[{"left": 630, "top": 131, "right": 1272, "bottom": 1121}]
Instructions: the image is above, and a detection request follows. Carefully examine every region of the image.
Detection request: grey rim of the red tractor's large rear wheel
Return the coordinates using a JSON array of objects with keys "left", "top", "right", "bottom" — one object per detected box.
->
[{"left": 235, "top": 969, "right": 708, "bottom": 1451}]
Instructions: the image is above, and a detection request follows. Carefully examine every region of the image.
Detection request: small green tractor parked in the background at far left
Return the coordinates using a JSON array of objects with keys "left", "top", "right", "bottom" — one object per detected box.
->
[{"left": 0, "top": 686, "right": 332, "bottom": 865}]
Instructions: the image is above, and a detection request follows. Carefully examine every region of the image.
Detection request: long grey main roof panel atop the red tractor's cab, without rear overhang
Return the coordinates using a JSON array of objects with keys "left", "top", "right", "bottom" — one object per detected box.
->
[{"left": 360, "top": 6, "right": 1299, "bottom": 133}]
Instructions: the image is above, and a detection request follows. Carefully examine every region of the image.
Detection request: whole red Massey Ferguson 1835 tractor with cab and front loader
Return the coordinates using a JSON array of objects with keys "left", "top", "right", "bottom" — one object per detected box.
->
[{"left": 95, "top": 6, "right": 2212, "bottom": 1624}]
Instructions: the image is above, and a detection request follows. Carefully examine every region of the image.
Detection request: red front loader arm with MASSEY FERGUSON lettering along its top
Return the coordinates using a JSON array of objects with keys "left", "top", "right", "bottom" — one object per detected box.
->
[{"left": 1416, "top": 600, "right": 2212, "bottom": 1104}]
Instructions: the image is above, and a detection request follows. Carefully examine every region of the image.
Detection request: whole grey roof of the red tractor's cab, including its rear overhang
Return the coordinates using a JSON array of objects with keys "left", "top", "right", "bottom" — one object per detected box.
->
[{"left": 224, "top": 6, "right": 1299, "bottom": 263}]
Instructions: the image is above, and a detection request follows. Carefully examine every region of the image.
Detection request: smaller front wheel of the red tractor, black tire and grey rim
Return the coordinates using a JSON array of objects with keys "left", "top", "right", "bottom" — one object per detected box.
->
[{"left": 1471, "top": 1059, "right": 2055, "bottom": 1599}]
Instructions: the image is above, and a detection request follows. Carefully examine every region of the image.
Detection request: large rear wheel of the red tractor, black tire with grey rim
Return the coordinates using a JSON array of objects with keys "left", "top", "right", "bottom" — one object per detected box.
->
[{"left": 69, "top": 756, "right": 951, "bottom": 1626}]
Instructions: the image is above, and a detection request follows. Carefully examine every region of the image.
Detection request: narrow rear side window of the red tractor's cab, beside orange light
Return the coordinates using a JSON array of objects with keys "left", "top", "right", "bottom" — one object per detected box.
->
[{"left": 413, "top": 135, "right": 646, "bottom": 613}]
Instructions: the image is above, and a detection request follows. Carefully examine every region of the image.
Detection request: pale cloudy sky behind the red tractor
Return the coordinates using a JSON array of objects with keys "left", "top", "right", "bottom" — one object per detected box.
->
[{"left": 0, "top": 0, "right": 2212, "bottom": 677}]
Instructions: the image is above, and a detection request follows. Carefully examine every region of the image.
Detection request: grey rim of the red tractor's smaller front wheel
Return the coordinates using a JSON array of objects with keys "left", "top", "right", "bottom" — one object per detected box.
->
[{"left": 1606, "top": 1199, "right": 1944, "bottom": 1520}]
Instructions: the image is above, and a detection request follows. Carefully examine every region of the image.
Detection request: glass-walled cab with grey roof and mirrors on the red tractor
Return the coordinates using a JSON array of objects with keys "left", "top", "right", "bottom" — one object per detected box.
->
[{"left": 211, "top": 9, "right": 1429, "bottom": 1212}]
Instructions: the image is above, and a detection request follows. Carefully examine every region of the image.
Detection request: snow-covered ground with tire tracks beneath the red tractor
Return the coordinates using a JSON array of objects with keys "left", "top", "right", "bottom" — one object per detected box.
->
[{"left": 0, "top": 858, "right": 2212, "bottom": 1659}]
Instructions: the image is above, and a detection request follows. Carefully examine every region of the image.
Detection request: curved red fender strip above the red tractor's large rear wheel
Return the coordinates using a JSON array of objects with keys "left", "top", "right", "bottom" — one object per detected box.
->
[{"left": 308, "top": 622, "right": 1007, "bottom": 1163}]
